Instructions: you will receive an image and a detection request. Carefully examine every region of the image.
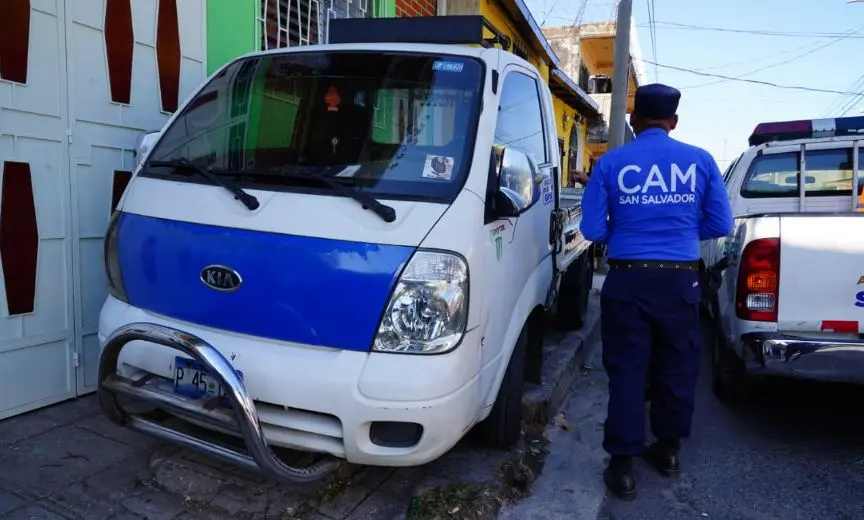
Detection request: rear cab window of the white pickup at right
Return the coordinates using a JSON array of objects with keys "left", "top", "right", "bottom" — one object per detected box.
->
[{"left": 741, "top": 148, "right": 864, "bottom": 198}]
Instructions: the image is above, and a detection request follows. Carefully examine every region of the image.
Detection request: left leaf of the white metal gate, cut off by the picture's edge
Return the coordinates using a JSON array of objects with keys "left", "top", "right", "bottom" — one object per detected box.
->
[{"left": 0, "top": 0, "right": 75, "bottom": 419}]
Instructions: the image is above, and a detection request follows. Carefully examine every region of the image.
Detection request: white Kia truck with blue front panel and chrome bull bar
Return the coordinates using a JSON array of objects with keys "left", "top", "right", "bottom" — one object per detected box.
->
[{"left": 98, "top": 17, "right": 592, "bottom": 482}]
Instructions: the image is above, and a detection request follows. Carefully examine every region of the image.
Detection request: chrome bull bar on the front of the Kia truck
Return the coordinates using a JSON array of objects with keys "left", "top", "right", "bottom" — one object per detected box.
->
[{"left": 97, "top": 323, "right": 340, "bottom": 484}]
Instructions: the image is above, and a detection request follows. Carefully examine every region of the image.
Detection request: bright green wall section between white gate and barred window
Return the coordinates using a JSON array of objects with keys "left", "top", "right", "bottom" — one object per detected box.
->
[{"left": 207, "top": 0, "right": 261, "bottom": 75}]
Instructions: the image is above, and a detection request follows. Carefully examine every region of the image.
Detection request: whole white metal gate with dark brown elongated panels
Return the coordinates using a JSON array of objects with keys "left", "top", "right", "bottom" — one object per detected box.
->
[{"left": 0, "top": 0, "right": 205, "bottom": 419}]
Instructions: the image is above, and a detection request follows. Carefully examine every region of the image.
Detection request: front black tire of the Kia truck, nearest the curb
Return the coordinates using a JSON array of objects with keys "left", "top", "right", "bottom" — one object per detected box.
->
[{"left": 476, "top": 326, "right": 528, "bottom": 450}]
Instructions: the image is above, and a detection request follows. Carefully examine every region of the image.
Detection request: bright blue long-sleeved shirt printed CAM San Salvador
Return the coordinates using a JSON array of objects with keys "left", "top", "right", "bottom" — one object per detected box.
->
[{"left": 579, "top": 128, "right": 733, "bottom": 261}]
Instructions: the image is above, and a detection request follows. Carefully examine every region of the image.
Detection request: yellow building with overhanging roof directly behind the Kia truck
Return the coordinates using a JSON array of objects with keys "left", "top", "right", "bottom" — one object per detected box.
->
[{"left": 439, "top": 0, "right": 602, "bottom": 186}]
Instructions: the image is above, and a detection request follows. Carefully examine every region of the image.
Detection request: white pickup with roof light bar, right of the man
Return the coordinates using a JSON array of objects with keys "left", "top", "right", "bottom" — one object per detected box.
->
[{"left": 702, "top": 117, "right": 864, "bottom": 399}]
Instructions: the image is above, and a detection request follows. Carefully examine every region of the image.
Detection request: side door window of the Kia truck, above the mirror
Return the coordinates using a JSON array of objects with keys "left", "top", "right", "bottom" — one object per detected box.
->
[{"left": 495, "top": 72, "right": 550, "bottom": 164}]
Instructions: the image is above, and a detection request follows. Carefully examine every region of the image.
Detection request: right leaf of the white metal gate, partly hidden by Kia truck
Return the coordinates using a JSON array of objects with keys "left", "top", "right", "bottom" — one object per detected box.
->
[{"left": 65, "top": 0, "right": 206, "bottom": 393}]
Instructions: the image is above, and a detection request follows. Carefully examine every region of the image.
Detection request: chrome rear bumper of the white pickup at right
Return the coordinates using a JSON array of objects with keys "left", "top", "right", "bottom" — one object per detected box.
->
[{"left": 741, "top": 332, "right": 864, "bottom": 384}]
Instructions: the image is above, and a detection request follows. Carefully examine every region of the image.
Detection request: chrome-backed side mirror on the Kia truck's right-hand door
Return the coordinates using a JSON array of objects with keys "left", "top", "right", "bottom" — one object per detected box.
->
[{"left": 494, "top": 147, "right": 539, "bottom": 217}]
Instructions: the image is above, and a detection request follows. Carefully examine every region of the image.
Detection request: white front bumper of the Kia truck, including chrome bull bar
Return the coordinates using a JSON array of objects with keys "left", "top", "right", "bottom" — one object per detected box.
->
[{"left": 99, "top": 298, "right": 483, "bottom": 482}]
